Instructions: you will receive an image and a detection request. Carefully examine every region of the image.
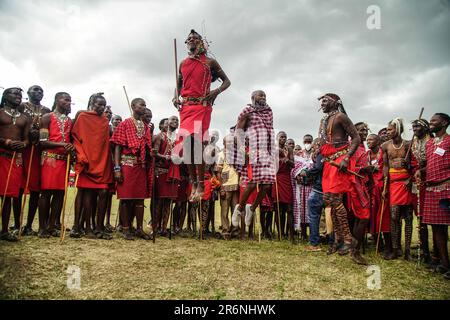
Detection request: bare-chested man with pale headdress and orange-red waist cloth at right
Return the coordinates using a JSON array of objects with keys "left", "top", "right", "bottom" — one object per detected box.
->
[{"left": 381, "top": 118, "right": 413, "bottom": 260}]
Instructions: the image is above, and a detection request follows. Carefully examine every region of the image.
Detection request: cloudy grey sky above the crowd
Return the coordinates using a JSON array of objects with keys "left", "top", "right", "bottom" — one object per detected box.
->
[{"left": 0, "top": 0, "right": 450, "bottom": 145}]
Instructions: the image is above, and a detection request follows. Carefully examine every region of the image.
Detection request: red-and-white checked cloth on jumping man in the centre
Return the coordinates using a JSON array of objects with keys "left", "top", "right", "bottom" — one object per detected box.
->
[{"left": 233, "top": 105, "right": 278, "bottom": 183}]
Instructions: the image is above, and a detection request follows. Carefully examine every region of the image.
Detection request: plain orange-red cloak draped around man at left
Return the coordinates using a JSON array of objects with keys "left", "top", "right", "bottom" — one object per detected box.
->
[{"left": 72, "top": 111, "right": 113, "bottom": 184}]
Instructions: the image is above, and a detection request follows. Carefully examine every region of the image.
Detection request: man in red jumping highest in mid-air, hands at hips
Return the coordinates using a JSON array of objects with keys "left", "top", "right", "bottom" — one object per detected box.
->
[{"left": 173, "top": 30, "right": 231, "bottom": 201}]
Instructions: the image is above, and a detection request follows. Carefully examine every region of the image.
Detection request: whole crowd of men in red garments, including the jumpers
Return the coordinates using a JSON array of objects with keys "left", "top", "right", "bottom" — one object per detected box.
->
[{"left": 0, "top": 30, "right": 450, "bottom": 279}]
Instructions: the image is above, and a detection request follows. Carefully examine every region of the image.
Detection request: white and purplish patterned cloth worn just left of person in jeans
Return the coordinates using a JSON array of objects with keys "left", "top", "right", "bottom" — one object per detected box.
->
[{"left": 291, "top": 157, "right": 314, "bottom": 230}]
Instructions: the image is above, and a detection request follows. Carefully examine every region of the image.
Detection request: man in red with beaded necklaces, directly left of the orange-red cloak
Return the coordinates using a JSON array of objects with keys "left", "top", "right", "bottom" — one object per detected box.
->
[{"left": 39, "top": 92, "right": 74, "bottom": 237}]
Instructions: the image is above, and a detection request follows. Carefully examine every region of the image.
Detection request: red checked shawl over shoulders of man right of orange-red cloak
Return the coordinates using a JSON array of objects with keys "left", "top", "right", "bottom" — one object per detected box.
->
[{"left": 110, "top": 118, "right": 152, "bottom": 161}]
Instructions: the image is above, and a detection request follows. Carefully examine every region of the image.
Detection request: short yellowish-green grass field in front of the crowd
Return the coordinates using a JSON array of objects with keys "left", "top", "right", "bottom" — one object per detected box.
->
[{"left": 0, "top": 189, "right": 450, "bottom": 299}]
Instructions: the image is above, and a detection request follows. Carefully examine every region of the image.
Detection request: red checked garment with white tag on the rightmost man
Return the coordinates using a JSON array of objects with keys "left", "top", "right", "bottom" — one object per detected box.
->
[{"left": 423, "top": 136, "right": 450, "bottom": 225}]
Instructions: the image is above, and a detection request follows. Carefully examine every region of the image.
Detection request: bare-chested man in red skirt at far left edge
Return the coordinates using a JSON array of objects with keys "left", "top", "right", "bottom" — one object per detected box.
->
[{"left": 0, "top": 88, "right": 31, "bottom": 241}]
